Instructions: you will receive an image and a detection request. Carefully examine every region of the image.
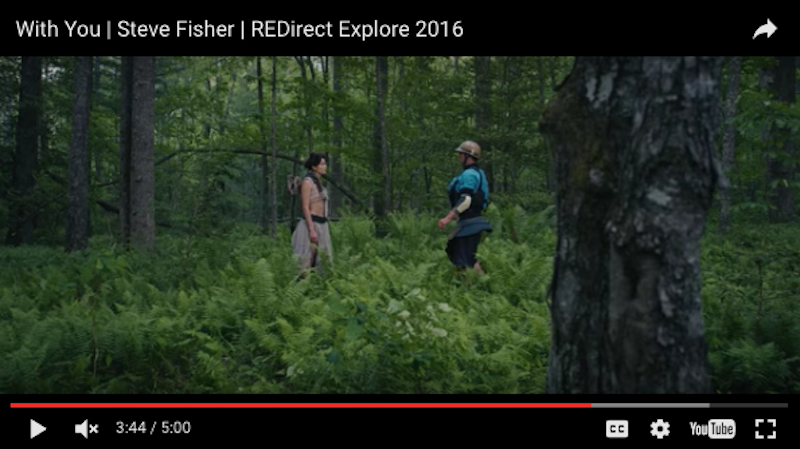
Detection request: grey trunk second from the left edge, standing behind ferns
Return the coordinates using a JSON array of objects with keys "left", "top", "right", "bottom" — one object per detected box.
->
[{"left": 66, "top": 56, "right": 92, "bottom": 251}]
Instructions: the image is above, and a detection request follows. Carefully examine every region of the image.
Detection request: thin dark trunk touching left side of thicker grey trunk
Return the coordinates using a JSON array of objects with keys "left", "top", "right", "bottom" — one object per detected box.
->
[{"left": 119, "top": 56, "right": 133, "bottom": 247}]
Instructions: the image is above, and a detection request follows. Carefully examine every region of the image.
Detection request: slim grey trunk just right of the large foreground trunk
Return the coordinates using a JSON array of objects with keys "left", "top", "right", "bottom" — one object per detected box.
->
[{"left": 719, "top": 56, "right": 742, "bottom": 234}]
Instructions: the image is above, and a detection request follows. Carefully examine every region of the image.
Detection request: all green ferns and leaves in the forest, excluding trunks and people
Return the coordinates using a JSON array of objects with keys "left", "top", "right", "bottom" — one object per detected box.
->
[{"left": 0, "top": 56, "right": 800, "bottom": 393}]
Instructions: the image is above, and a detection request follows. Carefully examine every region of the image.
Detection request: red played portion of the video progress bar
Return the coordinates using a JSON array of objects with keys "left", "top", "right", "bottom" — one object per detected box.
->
[{"left": 11, "top": 403, "right": 592, "bottom": 408}]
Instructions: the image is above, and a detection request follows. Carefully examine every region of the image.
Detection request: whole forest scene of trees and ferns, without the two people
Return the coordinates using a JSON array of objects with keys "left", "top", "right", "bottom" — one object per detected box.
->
[{"left": 0, "top": 56, "right": 800, "bottom": 394}]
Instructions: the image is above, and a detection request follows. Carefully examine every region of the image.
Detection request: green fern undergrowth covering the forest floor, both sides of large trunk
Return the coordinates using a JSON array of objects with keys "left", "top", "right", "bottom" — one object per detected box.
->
[{"left": 0, "top": 210, "right": 800, "bottom": 393}]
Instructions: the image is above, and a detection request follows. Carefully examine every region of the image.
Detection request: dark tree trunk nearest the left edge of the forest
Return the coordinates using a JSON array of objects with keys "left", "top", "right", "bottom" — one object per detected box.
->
[{"left": 6, "top": 56, "right": 42, "bottom": 246}]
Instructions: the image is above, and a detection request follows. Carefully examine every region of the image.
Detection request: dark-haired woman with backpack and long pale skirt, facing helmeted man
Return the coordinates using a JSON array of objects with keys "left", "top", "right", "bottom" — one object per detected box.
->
[{"left": 289, "top": 153, "right": 333, "bottom": 277}]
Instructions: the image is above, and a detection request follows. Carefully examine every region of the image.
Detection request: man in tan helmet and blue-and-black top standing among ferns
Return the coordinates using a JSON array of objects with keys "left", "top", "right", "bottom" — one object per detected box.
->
[{"left": 439, "top": 140, "right": 492, "bottom": 274}]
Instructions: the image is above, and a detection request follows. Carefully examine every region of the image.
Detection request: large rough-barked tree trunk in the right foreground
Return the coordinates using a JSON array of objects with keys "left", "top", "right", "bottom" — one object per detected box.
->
[{"left": 541, "top": 56, "right": 723, "bottom": 393}]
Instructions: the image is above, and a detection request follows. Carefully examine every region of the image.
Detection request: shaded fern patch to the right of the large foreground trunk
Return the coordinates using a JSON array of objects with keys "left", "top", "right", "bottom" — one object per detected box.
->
[{"left": 702, "top": 226, "right": 800, "bottom": 394}]
